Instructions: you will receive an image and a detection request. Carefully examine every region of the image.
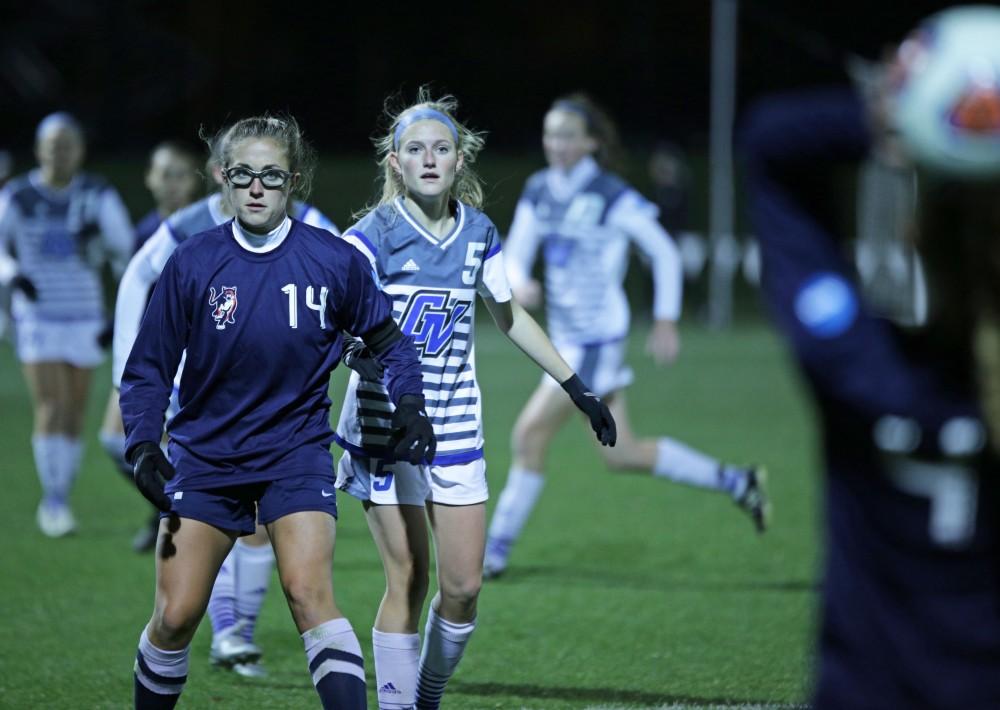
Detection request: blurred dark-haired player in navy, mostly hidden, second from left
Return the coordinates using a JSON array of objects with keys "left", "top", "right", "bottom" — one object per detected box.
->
[{"left": 99, "top": 136, "right": 202, "bottom": 552}]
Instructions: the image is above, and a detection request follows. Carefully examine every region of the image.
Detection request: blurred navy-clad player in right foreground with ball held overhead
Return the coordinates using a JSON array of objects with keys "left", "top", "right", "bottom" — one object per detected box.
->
[{"left": 741, "top": 6, "right": 1000, "bottom": 710}]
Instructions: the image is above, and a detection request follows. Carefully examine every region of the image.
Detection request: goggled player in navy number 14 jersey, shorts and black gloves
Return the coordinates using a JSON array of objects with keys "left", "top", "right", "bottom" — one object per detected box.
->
[{"left": 120, "top": 116, "right": 434, "bottom": 708}]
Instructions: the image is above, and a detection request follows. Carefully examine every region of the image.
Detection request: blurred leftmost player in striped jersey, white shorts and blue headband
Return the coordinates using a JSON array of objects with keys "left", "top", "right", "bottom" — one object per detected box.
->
[{"left": 0, "top": 113, "right": 135, "bottom": 537}]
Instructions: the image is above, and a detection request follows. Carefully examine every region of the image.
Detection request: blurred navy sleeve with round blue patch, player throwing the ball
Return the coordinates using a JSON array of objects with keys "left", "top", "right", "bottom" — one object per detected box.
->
[{"left": 739, "top": 90, "right": 978, "bottom": 443}]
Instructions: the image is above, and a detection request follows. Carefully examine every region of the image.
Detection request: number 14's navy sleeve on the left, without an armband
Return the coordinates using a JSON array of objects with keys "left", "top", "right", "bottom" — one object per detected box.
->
[{"left": 119, "top": 253, "right": 191, "bottom": 452}]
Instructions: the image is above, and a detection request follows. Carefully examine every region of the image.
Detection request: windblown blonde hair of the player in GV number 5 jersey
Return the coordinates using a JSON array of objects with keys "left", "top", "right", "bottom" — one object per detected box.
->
[{"left": 353, "top": 86, "right": 486, "bottom": 219}]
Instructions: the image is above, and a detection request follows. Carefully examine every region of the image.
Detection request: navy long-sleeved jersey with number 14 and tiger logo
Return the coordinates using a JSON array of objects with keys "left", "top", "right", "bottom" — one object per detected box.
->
[{"left": 121, "top": 220, "right": 423, "bottom": 491}]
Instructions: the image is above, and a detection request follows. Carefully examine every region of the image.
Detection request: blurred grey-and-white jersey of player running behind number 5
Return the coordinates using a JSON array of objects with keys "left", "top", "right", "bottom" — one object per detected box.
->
[{"left": 504, "top": 157, "right": 683, "bottom": 345}]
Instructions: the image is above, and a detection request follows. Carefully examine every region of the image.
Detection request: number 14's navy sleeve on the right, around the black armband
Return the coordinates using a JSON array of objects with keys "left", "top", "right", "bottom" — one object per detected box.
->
[{"left": 337, "top": 247, "right": 424, "bottom": 404}]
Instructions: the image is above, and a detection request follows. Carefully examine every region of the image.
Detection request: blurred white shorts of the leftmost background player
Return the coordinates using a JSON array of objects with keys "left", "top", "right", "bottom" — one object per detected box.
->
[{"left": 14, "top": 318, "right": 104, "bottom": 368}]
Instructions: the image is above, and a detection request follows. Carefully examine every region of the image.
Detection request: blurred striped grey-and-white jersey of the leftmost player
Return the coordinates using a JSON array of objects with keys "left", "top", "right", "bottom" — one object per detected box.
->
[{"left": 0, "top": 170, "right": 135, "bottom": 321}]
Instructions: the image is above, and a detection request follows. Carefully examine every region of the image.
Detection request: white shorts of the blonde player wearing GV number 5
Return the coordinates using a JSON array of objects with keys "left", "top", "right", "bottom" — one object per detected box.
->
[{"left": 337, "top": 451, "right": 490, "bottom": 506}]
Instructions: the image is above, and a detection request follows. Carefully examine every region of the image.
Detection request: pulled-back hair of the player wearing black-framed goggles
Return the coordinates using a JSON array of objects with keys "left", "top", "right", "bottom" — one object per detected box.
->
[{"left": 201, "top": 113, "right": 316, "bottom": 201}]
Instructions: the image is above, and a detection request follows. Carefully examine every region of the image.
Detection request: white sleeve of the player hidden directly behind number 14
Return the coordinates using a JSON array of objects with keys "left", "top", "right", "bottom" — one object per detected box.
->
[{"left": 111, "top": 222, "right": 177, "bottom": 387}]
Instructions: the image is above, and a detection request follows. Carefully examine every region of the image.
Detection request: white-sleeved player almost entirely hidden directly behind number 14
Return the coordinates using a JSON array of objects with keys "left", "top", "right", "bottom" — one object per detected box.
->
[{"left": 111, "top": 135, "right": 340, "bottom": 677}]
